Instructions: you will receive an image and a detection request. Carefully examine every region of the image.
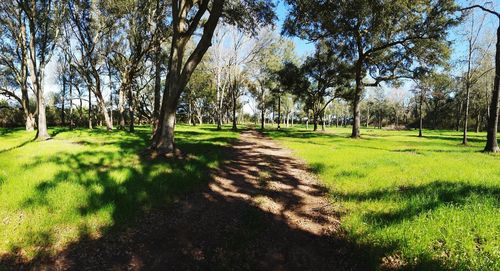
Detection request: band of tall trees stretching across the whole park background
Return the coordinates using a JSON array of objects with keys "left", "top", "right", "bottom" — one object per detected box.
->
[{"left": 0, "top": 0, "right": 498, "bottom": 154}]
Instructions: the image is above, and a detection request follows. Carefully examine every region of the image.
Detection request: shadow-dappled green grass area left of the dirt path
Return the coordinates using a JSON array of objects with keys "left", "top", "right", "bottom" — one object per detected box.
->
[{"left": 0, "top": 126, "right": 238, "bottom": 260}]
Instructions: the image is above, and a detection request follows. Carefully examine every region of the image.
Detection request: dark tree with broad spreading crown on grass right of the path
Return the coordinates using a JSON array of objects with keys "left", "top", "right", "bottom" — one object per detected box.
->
[{"left": 284, "top": 0, "right": 458, "bottom": 138}]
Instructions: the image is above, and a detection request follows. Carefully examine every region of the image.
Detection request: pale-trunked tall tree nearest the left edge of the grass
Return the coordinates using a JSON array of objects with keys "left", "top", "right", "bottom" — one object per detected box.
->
[{"left": 0, "top": 0, "right": 65, "bottom": 140}]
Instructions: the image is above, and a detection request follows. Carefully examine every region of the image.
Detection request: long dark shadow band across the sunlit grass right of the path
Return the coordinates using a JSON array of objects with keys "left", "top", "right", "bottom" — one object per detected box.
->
[{"left": 331, "top": 180, "right": 500, "bottom": 270}]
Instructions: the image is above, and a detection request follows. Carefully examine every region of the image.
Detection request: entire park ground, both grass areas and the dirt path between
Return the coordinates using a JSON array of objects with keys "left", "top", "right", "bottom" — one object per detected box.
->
[{"left": 0, "top": 126, "right": 500, "bottom": 270}]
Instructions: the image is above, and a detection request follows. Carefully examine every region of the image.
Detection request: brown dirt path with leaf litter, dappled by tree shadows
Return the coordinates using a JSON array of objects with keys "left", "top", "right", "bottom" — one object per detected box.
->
[{"left": 19, "top": 131, "right": 361, "bottom": 270}]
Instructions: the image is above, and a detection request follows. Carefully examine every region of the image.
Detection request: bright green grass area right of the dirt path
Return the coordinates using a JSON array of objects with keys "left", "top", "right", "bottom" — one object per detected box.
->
[{"left": 267, "top": 128, "right": 500, "bottom": 270}]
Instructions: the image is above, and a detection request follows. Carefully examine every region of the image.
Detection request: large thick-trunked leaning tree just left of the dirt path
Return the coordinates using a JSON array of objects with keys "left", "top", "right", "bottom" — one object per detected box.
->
[{"left": 151, "top": 0, "right": 275, "bottom": 154}]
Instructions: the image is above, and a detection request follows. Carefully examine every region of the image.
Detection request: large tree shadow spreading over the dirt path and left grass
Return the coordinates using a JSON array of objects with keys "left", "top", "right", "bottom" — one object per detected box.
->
[{"left": 0, "top": 132, "right": 446, "bottom": 270}]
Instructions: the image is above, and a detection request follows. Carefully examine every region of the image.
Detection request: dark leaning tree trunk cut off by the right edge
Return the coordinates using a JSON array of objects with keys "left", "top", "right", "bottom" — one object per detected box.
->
[{"left": 484, "top": 22, "right": 500, "bottom": 152}]
